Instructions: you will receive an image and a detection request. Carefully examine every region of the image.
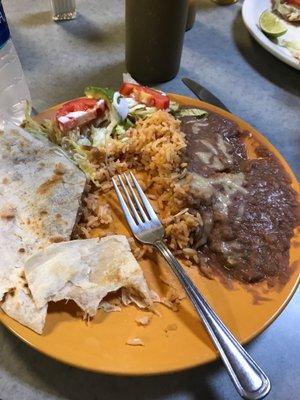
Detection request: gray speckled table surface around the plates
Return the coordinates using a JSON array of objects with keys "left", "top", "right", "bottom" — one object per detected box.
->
[{"left": 0, "top": 0, "right": 300, "bottom": 400}]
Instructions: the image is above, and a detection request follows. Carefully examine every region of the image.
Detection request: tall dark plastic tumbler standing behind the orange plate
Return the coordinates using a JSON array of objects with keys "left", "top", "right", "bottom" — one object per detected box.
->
[{"left": 126, "top": 0, "right": 188, "bottom": 84}]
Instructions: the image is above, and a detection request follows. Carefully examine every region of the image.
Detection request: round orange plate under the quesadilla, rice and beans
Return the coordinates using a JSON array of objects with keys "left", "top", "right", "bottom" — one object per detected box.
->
[{"left": 0, "top": 95, "right": 300, "bottom": 375}]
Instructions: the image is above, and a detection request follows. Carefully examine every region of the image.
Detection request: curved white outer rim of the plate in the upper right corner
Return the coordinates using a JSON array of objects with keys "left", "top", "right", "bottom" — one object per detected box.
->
[{"left": 242, "top": 0, "right": 300, "bottom": 71}]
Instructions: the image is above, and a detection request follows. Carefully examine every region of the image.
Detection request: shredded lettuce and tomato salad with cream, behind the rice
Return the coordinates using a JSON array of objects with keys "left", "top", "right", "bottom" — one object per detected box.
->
[{"left": 23, "top": 74, "right": 206, "bottom": 185}]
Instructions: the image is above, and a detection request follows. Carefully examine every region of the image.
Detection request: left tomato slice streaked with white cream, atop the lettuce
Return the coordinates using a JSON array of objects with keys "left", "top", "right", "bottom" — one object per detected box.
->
[{"left": 55, "top": 98, "right": 106, "bottom": 132}]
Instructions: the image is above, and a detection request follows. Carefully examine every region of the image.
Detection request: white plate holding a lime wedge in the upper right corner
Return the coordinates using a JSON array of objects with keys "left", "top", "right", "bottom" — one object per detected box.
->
[{"left": 242, "top": 0, "right": 300, "bottom": 70}]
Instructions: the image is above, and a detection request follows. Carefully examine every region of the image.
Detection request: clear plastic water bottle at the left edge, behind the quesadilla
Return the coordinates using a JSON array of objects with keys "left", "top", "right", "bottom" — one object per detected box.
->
[{"left": 0, "top": 0, "right": 31, "bottom": 129}]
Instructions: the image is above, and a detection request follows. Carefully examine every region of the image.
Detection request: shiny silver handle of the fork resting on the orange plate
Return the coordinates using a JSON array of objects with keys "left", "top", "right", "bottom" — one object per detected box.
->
[{"left": 154, "top": 241, "right": 271, "bottom": 400}]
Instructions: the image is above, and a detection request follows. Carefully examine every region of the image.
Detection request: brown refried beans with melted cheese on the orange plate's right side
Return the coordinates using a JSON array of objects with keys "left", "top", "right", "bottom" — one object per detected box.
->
[{"left": 181, "top": 113, "right": 299, "bottom": 282}]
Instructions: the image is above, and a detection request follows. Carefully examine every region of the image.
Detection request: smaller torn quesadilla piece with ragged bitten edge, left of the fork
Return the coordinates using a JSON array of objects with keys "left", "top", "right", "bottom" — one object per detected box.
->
[{"left": 25, "top": 235, "right": 154, "bottom": 332}]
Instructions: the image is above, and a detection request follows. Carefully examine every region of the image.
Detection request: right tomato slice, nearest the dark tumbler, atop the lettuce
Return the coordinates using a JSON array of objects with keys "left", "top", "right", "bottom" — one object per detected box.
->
[{"left": 120, "top": 83, "right": 170, "bottom": 110}]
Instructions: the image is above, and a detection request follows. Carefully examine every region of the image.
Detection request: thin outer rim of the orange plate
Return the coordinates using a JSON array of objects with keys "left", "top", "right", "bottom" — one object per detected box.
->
[{"left": 0, "top": 93, "right": 300, "bottom": 377}]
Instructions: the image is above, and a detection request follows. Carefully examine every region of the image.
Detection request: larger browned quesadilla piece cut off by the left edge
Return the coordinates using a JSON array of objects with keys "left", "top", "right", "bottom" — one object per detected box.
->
[{"left": 0, "top": 125, "right": 86, "bottom": 331}]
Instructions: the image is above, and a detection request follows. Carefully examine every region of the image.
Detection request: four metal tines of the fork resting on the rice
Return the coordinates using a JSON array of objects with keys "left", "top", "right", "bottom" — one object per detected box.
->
[{"left": 112, "top": 172, "right": 158, "bottom": 229}]
